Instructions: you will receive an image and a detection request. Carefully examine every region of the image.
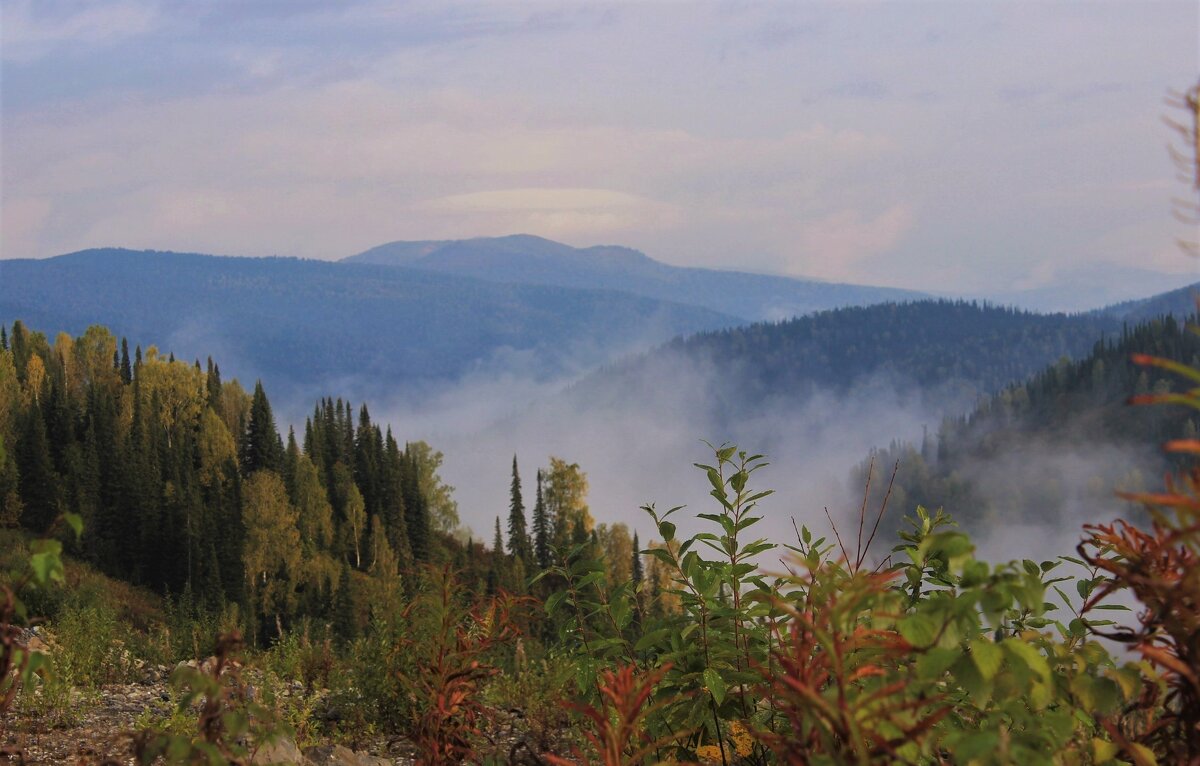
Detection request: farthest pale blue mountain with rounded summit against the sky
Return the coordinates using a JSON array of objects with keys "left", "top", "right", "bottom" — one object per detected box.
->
[{"left": 346, "top": 234, "right": 928, "bottom": 321}]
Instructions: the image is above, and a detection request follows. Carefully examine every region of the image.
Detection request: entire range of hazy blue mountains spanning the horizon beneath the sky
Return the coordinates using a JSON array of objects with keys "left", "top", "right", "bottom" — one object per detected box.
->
[{"left": 0, "top": 235, "right": 1193, "bottom": 420}]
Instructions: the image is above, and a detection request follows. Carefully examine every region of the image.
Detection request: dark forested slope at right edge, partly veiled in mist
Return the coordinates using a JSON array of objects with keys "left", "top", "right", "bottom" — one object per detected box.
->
[{"left": 851, "top": 316, "right": 1200, "bottom": 530}]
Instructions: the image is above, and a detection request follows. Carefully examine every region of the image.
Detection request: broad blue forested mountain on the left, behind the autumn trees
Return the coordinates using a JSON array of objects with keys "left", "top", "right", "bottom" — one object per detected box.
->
[{"left": 0, "top": 250, "right": 737, "bottom": 408}]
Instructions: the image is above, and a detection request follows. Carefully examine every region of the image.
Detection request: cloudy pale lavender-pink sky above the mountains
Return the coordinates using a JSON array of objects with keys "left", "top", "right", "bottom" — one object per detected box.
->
[{"left": 0, "top": 0, "right": 1200, "bottom": 292}]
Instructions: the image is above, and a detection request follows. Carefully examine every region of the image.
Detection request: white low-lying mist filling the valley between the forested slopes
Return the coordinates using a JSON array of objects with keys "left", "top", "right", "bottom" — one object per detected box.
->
[{"left": 302, "top": 351, "right": 1153, "bottom": 573}]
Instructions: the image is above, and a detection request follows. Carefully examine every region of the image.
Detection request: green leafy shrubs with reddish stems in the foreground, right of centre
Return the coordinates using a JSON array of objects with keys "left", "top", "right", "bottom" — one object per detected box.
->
[{"left": 546, "top": 447, "right": 1166, "bottom": 764}]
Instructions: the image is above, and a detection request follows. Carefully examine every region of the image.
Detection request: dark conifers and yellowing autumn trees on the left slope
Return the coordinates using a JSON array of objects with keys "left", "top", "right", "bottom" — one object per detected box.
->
[{"left": 0, "top": 322, "right": 657, "bottom": 639}]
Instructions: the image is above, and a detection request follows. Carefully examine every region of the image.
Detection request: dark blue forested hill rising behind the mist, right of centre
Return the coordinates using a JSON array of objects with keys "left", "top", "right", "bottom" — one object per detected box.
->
[{"left": 571, "top": 300, "right": 1121, "bottom": 419}]
